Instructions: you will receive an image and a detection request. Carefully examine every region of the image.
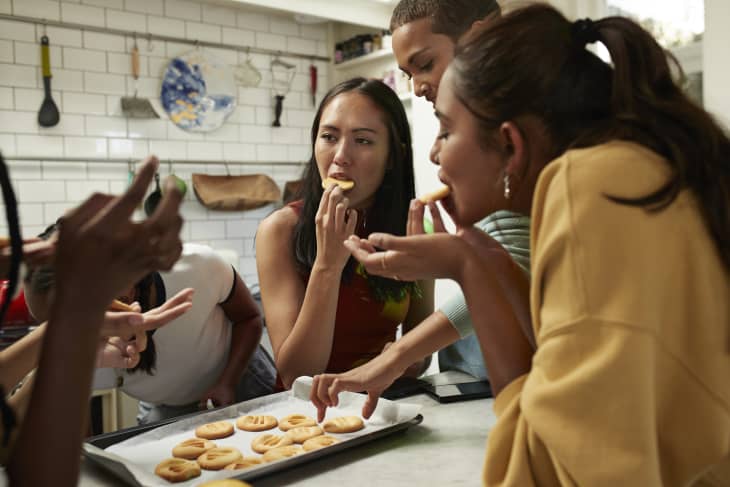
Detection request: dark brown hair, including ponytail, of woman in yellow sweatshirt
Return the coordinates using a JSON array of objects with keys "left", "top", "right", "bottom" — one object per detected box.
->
[{"left": 451, "top": 5, "right": 730, "bottom": 268}]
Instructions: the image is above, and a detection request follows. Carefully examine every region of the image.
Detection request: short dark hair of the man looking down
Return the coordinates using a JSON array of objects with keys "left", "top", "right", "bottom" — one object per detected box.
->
[{"left": 390, "top": 0, "right": 500, "bottom": 43}]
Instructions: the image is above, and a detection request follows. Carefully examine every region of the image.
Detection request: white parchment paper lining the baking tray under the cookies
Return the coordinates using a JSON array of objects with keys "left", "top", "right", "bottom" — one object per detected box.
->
[{"left": 84, "top": 377, "right": 422, "bottom": 487}]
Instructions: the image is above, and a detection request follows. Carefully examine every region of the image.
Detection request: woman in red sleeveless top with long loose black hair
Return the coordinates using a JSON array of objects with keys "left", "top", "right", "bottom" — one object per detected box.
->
[{"left": 256, "top": 78, "right": 432, "bottom": 387}]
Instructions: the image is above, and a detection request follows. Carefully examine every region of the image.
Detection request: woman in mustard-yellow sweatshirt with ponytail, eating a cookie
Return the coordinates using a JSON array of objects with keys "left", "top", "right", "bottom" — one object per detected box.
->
[{"left": 315, "top": 5, "right": 730, "bottom": 486}]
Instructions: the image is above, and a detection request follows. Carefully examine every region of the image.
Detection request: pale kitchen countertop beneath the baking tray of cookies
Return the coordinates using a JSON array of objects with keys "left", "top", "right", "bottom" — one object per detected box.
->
[{"left": 79, "top": 394, "right": 496, "bottom": 487}]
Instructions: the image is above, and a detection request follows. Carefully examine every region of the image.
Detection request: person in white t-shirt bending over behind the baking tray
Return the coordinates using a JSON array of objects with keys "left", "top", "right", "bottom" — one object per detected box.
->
[{"left": 27, "top": 243, "right": 276, "bottom": 424}]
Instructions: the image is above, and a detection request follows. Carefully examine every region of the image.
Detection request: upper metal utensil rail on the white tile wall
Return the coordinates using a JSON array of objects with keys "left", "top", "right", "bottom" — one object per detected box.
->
[{"left": 0, "top": 14, "right": 330, "bottom": 62}]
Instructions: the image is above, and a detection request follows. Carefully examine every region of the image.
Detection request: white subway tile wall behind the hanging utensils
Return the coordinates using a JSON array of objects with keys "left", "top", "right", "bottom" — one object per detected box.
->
[{"left": 0, "top": 0, "right": 329, "bottom": 285}]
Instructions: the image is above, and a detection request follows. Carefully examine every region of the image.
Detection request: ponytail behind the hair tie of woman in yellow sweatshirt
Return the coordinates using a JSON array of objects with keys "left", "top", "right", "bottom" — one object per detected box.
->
[{"left": 596, "top": 17, "right": 730, "bottom": 269}]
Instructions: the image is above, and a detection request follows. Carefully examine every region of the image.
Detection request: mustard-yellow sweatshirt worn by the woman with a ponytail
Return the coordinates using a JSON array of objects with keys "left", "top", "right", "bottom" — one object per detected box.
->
[{"left": 484, "top": 142, "right": 730, "bottom": 487}]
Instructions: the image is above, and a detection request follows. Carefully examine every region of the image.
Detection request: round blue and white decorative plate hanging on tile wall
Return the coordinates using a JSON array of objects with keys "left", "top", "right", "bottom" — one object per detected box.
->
[{"left": 160, "top": 49, "right": 236, "bottom": 132}]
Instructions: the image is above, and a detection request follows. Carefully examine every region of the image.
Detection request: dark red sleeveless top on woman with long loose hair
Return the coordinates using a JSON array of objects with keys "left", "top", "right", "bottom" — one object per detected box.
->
[{"left": 288, "top": 201, "right": 411, "bottom": 373}]
